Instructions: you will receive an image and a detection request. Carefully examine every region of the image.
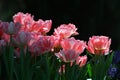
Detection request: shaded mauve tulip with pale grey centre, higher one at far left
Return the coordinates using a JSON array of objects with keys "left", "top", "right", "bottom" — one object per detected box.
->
[{"left": 2, "top": 22, "right": 21, "bottom": 35}]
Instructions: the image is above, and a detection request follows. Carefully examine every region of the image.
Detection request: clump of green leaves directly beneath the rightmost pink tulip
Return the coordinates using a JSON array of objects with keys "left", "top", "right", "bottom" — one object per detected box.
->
[{"left": 88, "top": 53, "right": 113, "bottom": 80}]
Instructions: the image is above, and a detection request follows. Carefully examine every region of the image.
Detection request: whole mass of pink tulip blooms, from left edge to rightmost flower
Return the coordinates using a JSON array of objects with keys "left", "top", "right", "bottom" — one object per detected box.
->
[{"left": 0, "top": 12, "right": 111, "bottom": 80}]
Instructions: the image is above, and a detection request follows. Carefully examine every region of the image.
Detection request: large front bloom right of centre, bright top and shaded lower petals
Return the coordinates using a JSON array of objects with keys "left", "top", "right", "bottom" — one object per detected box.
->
[{"left": 55, "top": 38, "right": 86, "bottom": 62}]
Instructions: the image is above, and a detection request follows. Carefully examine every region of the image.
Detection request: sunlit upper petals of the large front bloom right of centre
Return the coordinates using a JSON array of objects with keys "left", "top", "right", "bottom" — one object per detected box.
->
[{"left": 61, "top": 37, "right": 86, "bottom": 53}]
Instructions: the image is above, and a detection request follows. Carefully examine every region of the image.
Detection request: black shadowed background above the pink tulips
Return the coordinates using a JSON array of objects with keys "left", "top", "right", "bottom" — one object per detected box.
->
[{"left": 0, "top": 0, "right": 120, "bottom": 50}]
